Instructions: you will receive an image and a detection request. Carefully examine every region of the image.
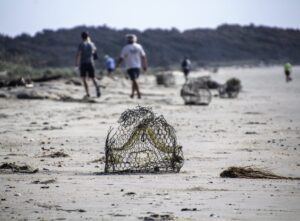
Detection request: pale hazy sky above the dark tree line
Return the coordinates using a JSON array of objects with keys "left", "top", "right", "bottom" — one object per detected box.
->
[{"left": 0, "top": 0, "right": 300, "bottom": 36}]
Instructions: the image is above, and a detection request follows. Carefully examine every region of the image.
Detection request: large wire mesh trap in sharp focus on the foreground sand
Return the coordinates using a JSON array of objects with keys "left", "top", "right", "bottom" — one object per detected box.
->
[{"left": 104, "top": 106, "right": 184, "bottom": 173}]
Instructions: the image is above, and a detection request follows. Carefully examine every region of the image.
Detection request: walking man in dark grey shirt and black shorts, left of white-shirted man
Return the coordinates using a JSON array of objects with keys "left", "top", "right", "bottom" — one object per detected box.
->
[{"left": 76, "top": 32, "right": 101, "bottom": 97}]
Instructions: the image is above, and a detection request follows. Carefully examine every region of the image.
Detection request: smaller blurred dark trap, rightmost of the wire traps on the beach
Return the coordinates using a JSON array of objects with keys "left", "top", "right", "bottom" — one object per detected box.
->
[{"left": 219, "top": 78, "right": 242, "bottom": 98}]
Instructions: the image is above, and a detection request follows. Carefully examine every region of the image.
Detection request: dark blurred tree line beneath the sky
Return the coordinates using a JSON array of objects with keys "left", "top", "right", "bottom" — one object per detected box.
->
[{"left": 0, "top": 25, "right": 300, "bottom": 67}]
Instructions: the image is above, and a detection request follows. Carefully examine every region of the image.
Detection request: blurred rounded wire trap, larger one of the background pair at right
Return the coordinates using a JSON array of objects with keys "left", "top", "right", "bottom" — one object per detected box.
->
[{"left": 180, "top": 77, "right": 212, "bottom": 105}]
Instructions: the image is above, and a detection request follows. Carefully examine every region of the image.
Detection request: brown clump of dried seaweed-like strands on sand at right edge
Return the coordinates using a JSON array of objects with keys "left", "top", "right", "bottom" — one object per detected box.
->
[{"left": 220, "top": 166, "right": 300, "bottom": 180}]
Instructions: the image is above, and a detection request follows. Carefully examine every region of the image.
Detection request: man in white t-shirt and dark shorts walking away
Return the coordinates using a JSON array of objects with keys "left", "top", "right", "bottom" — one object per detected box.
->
[{"left": 116, "top": 34, "right": 148, "bottom": 99}]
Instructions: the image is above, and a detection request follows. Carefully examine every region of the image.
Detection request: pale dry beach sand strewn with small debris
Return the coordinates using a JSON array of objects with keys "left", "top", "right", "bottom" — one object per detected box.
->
[{"left": 0, "top": 64, "right": 300, "bottom": 220}]
